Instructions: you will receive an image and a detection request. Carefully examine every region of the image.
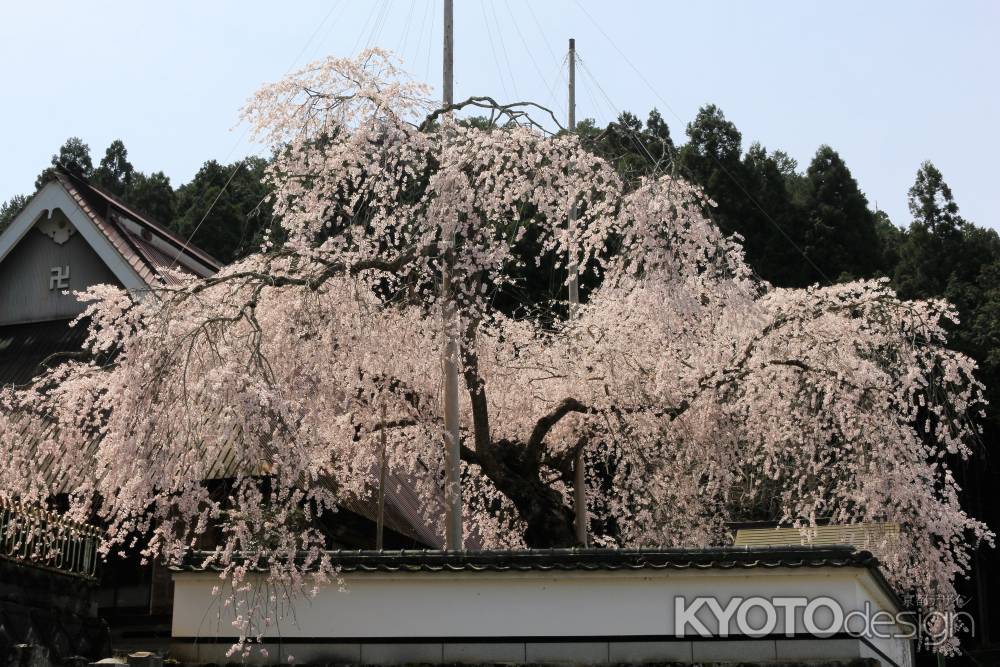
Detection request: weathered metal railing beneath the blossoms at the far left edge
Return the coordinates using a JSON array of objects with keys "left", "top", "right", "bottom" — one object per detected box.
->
[{"left": 0, "top": 498, "right": 101, "bottom": 579}]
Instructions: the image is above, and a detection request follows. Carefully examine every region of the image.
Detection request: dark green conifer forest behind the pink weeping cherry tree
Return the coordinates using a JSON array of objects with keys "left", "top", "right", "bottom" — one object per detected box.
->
[{"left": 13, "top": 130, "right": 1000, "bottom": 423}]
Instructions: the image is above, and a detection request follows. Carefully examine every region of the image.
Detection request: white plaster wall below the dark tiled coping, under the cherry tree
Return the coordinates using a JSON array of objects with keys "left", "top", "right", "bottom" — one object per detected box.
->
[{"left": 172, "top": 568, "right": 909, "bottom": 665}]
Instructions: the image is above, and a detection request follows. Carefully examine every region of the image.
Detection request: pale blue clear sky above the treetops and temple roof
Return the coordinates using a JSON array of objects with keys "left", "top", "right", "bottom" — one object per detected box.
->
[{"left": 0, "top": 0, "right": 1000, "bottom": 229}]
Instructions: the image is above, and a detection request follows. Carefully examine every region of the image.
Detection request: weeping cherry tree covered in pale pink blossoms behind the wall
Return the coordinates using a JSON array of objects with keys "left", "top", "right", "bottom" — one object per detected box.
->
[{"left": 0, "top": 50, "right": 992, "bottom": 652}]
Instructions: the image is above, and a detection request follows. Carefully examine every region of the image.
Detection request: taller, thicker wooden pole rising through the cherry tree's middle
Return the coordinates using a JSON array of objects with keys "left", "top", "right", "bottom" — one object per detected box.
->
[{"left": 441, "top": 0, "right": 462, "bottom": 551}]
